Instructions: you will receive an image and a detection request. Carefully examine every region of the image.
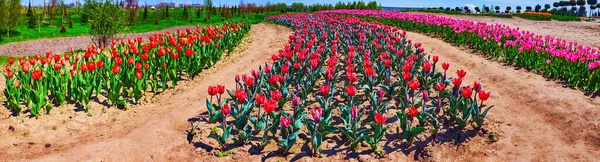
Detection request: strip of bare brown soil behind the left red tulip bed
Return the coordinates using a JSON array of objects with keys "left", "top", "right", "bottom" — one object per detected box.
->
[{"left": 0, "top": 26, "right": 195, "bottom": 56}]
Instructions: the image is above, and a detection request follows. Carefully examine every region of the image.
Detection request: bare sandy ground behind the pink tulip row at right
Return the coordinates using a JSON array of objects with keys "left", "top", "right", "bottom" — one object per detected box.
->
[{"left": 424, "top": 14, "right": 600, "bottom": 48}]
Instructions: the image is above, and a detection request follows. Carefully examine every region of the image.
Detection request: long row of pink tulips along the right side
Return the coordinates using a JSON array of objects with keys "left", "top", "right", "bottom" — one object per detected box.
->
[{"left": 322, "top": 10, "right": 600, "bottom": 92}]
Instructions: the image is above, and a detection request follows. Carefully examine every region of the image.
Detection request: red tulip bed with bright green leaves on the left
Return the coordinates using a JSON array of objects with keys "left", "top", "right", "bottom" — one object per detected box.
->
[{"left": 4, "top": 20, "right": 250, "bottom": 118}]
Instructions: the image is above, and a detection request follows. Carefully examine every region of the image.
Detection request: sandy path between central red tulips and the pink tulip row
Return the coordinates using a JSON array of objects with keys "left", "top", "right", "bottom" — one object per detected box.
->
[{"left": 408, "top": 33, "right": 600, "bottom": 161}]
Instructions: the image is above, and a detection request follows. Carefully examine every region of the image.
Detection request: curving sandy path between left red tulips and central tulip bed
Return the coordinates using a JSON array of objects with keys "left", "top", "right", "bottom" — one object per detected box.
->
[{"left": 0, "top": 24, "right": 291, "bottom": 161}]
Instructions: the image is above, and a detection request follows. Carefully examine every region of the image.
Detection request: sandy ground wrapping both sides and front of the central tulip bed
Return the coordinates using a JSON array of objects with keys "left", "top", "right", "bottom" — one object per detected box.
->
[{"left": 0, "top": 24, "right": 600, "bottom": 161}]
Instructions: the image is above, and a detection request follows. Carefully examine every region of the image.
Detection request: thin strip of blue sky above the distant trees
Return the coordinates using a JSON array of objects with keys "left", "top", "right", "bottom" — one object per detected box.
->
[{"left": 21, "top": 0, "right": 558, "bottom": 8}]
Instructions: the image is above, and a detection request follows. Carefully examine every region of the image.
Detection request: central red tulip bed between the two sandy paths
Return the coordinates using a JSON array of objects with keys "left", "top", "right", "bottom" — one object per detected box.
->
[{"left": 206, "top": 14, "right": 493, "bottom": 156}]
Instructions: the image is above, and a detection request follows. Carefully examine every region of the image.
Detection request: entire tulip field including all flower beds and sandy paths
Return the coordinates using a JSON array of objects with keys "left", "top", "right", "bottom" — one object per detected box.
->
[{"left": 0, "top": 6, "right": 600, "bottom": 162}]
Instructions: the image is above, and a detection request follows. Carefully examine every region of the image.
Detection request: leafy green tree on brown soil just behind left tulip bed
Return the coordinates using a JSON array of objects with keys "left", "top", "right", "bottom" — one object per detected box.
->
[{"left": 84, "top": 0, "right": 124, "bottom": 46}]
